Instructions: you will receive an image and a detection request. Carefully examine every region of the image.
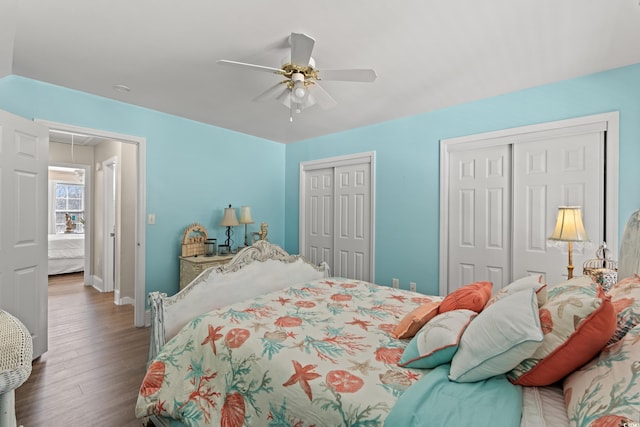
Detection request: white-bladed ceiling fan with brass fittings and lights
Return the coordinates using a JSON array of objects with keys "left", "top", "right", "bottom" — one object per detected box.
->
[{"left": 218, "top": 33, "right": 376, "bottom": 121}]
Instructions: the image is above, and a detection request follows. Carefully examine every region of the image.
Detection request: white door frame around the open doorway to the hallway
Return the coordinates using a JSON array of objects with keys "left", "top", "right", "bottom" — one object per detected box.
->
[{"left": 34, "top": 119, "right": 147, "bottom": 327}]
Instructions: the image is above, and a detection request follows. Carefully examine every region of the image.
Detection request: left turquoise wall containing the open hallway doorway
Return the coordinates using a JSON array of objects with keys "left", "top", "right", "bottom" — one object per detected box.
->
[{"left": 0, "top": 76, "right": 285, "bottom": 294}]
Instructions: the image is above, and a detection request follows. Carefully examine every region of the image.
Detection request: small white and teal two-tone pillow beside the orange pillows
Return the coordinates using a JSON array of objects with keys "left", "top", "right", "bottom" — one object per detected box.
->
[{"left": 398, "top": 309, "right": 476, "bottom": 369}]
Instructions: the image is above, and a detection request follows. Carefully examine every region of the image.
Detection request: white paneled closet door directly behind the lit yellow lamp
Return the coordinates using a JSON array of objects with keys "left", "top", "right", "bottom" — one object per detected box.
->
[{"left": 513, "top": 131, "right": 605, "bottom": 284}]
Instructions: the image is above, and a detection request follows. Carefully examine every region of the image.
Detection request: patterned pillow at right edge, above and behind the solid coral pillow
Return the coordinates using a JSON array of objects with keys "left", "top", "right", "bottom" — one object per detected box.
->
[{"left": 607, "top": 274, "right": 640, "bottom": 344}]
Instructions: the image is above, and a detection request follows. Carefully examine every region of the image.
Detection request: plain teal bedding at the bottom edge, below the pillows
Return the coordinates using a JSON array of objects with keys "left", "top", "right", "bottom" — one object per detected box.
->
[{"left": 384, "top": 365, "right": 522, "bottom": 427}]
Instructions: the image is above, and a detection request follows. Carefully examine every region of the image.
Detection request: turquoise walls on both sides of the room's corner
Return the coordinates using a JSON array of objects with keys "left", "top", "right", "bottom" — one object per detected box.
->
[{"left": 0, "top": 64, "right": 640, "bottom": 300}]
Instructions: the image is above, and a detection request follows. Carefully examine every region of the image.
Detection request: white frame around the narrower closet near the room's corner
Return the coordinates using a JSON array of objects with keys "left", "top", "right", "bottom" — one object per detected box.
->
[{"left": 298, "top": 151, "right": 376, "bottom": 282}]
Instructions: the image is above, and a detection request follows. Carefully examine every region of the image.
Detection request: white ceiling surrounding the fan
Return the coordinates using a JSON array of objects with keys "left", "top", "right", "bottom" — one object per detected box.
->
[{"left": 0, "top": 0, "right": 640, "bottom": 143}]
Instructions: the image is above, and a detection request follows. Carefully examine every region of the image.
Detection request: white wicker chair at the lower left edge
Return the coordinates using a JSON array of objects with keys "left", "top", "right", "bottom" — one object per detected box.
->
[{"left": 0, "top": 310, "right": 33, "bottom": 427}]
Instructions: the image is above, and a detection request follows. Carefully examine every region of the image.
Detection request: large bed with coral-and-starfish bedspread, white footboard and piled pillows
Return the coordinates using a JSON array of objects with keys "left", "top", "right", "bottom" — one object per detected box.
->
[{"left": 136, "top": 234, "right": 640, "bottom": 427}]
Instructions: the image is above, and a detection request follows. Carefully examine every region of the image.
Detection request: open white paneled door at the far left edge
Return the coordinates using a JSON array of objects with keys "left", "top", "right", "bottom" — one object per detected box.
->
[{"left": 0, "top": 111, "right": 49, "bottom": 358}]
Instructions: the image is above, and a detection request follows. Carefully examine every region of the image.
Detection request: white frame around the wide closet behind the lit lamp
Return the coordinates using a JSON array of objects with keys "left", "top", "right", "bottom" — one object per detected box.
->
[{"left": 439, "top": 111, "right": 620, "bottom": 295}]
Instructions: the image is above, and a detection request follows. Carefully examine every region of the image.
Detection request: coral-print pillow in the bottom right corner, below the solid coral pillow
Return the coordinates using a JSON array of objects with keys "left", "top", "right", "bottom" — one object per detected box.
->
[{"left": 563, "top": 326, "right": 640, "bottom": 427}]
